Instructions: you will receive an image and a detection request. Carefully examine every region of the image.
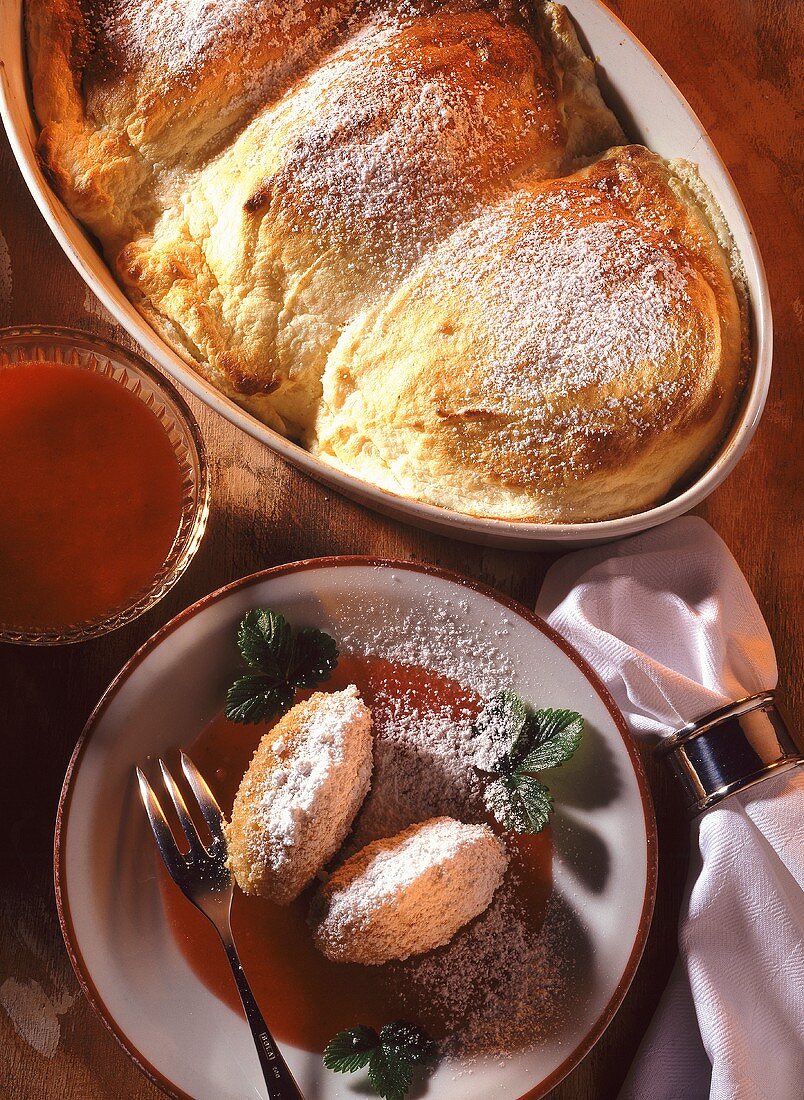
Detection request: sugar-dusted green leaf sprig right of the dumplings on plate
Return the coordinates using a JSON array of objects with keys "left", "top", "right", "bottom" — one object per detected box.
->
[{"left": 474, "top": 689, "right": 584, "bottom": 834}]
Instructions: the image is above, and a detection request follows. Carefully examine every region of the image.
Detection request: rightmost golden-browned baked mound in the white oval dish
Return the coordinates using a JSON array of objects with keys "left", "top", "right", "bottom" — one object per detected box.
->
[{"left": 313, "top": 146, "right": 741, "bottom": 521}]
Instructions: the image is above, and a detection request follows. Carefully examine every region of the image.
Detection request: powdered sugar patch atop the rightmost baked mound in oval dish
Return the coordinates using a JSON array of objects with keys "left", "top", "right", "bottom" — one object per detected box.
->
[{"left": 421, "top": 182, "right": 691, "bottom": 419}]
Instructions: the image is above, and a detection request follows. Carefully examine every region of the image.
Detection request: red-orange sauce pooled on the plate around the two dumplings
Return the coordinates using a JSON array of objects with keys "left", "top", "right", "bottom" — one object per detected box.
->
[{"left": 160, "top": 656, "right": 552, "bottom": 1052}]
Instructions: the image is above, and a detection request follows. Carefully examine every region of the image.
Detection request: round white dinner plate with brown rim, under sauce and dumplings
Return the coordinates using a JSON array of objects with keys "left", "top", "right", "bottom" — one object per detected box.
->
[{"left": 55, "top": 558, "right": 657, "bottom": 1100}]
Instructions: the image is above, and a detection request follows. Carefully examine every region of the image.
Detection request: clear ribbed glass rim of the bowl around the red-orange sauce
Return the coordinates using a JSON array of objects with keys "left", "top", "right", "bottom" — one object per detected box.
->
[{"left": 0, "top": 326, "right": 209, "bottom": 646}]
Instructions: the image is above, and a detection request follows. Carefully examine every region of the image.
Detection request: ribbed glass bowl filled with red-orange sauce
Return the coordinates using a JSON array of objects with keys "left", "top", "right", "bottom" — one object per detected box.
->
[{"left": 0, "top": 330, "right": 208, "bottom": 642}]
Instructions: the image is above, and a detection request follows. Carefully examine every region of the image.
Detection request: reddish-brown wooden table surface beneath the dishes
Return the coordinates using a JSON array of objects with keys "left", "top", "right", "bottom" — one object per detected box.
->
[{"left": 0, "top": 0, "right": 804, "bottom": 1100}]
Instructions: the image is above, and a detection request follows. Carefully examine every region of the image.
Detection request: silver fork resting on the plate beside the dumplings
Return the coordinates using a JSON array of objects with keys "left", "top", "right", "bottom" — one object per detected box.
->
[{"left": 136, "top": 752, "right": 304, "bottom": 1100}]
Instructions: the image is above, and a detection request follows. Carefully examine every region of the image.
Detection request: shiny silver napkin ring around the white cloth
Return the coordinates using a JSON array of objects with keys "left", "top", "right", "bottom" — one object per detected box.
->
[{"left": 656, "top": 691, "right": 804, "bottom": 817}]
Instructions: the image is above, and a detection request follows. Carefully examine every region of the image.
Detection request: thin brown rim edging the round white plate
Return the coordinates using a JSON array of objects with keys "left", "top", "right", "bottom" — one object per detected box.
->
[{"left": 53, "top": 554, "right": 658, "bottom": 1100}]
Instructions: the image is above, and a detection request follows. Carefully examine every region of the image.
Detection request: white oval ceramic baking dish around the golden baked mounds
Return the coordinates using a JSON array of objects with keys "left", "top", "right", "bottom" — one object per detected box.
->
[{"left": 0, "top": 0, "right": 772, "bottom": 549}]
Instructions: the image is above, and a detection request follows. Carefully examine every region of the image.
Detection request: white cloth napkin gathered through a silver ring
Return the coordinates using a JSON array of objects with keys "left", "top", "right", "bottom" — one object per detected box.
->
[{"left": 537, "top": 517, "right": 804, "bottom": 1100}]
